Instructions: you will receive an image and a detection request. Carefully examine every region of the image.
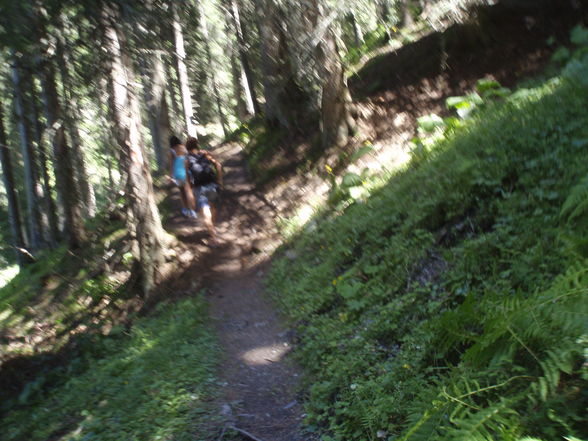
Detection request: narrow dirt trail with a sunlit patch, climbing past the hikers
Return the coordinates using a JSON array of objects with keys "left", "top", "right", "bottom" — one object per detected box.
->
[{"left": 166, "top": 144, "right": 302, "bottom": 441}]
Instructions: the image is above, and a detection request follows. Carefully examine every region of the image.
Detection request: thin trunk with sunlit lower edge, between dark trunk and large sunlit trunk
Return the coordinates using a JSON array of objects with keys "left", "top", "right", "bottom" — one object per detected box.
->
[{"left": 56, "top": 24, "right": 96, "bottom": 217}]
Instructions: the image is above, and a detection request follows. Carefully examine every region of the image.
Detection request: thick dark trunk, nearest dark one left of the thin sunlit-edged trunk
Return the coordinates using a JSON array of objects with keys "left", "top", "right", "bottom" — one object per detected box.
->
[{"left": 40, "top": 51, "right": 86, "bottom": 248}]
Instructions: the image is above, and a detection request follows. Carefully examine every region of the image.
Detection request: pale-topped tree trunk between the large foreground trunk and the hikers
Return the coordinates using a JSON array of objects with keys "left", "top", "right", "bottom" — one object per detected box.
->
[{"left": 144, "top": 52, "right": 171, "bottom": 175}]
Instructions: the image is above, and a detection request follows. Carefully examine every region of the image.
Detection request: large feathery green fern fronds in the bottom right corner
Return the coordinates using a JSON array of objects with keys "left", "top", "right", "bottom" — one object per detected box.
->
[{"left": 401, "top": 262, "right": 588, "bottom": 441}]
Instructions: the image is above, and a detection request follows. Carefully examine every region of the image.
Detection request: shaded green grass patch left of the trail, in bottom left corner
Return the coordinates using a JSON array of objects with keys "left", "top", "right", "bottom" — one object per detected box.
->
[{"left": 0, "top": 296, "right": 218, "bottom": 441}]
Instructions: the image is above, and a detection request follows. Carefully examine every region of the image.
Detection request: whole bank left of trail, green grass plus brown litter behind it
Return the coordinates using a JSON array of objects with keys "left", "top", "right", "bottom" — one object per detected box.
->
[{"left": 0, "top": 197, "right": 220, "bottom": 441}]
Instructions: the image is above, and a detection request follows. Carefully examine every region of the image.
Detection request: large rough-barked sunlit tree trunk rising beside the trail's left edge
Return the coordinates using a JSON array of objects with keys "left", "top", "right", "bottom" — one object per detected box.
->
[{"left": 103, "top": 6, "right": 167, "bottom": 296}]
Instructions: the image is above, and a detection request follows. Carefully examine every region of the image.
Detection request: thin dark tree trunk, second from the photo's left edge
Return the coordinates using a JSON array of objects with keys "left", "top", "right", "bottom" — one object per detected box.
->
[{"left": 12, "top": 51, "right": 43, "bottom": 250}]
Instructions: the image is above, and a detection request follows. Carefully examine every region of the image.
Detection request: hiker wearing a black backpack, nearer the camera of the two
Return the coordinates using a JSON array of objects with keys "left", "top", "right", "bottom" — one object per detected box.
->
[{"left": 186, "top": 137, "right": 223, "bottom": 243}]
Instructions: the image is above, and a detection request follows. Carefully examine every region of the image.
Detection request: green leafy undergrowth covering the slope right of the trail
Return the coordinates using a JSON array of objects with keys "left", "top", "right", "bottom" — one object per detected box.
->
[{"left": 268, "top": 30, "right": 588, "bottom": 441}]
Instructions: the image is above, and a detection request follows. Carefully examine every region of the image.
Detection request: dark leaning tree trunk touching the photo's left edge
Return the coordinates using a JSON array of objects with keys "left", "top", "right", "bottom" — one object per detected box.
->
[{"left": 0, "top": 102, "right": 31, "bottom": 267}]
